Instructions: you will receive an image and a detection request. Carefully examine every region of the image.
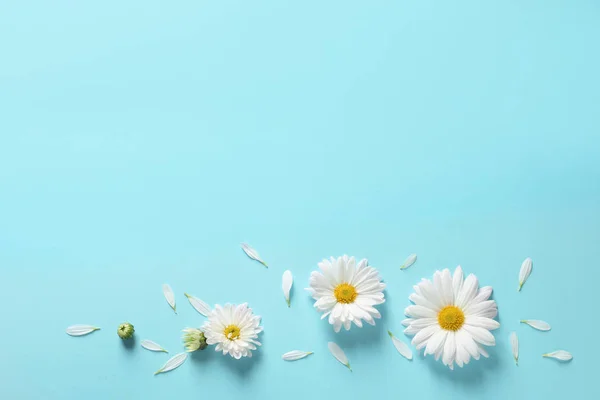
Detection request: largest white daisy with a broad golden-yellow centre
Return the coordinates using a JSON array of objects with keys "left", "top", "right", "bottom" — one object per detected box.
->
[{"left": 402, "top": 266, "right": 500, "bottom": 369}]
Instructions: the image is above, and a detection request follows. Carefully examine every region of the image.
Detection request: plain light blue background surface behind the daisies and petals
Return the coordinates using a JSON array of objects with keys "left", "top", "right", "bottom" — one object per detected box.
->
[{"left": 0, "top": 0, "right": 600, "bottom": 400}]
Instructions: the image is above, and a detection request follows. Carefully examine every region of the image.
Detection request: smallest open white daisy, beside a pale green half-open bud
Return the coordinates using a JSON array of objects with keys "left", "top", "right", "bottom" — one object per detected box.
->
[{"left": 202, "top": 303, "right": 263, "bottom": 360}]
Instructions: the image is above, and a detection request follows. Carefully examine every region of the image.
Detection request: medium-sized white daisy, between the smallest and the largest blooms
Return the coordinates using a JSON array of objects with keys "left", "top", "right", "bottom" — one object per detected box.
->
[{"left": 306, "top": 256, "right": 385, "bottom": 332}]
